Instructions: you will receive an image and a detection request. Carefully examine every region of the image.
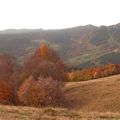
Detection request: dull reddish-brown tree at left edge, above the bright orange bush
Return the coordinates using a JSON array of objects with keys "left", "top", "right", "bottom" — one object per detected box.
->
[{"left": 0, "top": 53, "right": 21, "bottom": 102}]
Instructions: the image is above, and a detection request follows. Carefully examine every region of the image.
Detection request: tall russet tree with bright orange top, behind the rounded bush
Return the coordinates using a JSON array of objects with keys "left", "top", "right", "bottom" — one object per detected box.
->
[{"left": 21, "top": 44, "right": 67, "bottom": 81}]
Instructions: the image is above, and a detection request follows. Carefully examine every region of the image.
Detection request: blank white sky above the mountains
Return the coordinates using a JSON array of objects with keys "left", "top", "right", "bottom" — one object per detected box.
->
[{"left": 0, "top": 0, "right": 120, "bottom": 30}]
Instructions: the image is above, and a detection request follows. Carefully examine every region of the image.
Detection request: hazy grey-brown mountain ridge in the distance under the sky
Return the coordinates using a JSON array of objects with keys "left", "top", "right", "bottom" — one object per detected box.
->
[{"left": 0, "top": 23, "right": 120, "bottom": 67}]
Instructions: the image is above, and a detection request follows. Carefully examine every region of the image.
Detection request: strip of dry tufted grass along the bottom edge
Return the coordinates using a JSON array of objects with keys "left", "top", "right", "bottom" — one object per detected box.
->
[{"left": 0, "top": 105, "right": 120, "bottom": 120}]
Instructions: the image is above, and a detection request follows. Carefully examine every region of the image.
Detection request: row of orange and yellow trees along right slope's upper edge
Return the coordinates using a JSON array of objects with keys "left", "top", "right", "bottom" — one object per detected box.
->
[{"left": 68, "top": 64, "right": 120, "bottom": 81}]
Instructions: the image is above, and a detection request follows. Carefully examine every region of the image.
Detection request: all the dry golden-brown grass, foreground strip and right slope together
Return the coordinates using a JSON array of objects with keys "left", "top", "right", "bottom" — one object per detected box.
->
[{"left": 0, "top": 75, "right": 120, "bottom": 120}]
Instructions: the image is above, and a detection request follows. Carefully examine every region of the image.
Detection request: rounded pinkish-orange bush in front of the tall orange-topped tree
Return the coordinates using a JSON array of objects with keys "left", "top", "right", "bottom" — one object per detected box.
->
[{"left": 18, "top": 76, "right": 64, "bottom": 107}]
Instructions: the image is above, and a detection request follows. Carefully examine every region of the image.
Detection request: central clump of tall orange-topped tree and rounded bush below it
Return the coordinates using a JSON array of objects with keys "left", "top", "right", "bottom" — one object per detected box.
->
[{"left": 18, "top": 44, "right": 67, "bottom": 106}]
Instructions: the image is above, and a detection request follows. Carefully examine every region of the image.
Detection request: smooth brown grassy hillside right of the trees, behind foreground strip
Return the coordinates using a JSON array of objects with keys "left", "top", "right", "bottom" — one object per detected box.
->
[{"left": 66, "top": 75, "right": 120, "bottom": 112}]
